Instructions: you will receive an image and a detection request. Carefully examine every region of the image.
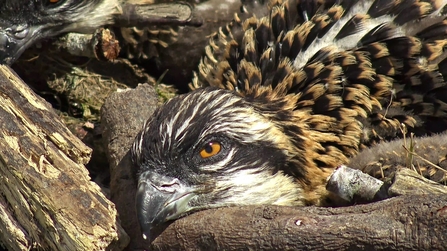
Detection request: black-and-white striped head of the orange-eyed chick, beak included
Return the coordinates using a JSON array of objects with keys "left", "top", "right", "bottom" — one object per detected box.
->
[{"left": 131, "top": 87, "right": 332, "bottom": 238}]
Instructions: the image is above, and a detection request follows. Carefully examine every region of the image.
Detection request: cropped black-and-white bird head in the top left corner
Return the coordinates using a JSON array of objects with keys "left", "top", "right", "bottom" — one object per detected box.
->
[{"left": 0, "top": 0, "right": 118, "bottom": 64}]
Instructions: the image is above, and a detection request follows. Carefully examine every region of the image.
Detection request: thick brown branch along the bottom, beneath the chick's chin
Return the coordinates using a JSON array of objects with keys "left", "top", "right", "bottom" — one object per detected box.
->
[{"left": 151, "top": 195, "right": 447, "bottom": 250}]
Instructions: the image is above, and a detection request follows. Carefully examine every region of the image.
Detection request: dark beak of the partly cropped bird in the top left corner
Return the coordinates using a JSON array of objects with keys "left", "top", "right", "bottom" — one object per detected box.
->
[{"left": 0, "top": 25, "right": 41, "bottom": 65}]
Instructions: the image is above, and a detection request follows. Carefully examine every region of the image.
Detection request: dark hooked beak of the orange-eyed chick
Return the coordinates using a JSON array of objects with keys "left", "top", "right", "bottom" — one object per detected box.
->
[{"left": 136, "top": 171, "right": 195, "bottom": 239}]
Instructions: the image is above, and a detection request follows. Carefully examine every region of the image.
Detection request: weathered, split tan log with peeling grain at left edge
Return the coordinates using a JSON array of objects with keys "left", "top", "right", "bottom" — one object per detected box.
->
[{"left": 0, "top": 65, "right": 128, "bottom": 250}]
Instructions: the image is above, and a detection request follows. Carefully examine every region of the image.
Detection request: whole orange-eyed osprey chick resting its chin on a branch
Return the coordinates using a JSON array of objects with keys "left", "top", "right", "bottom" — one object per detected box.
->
[{"left": 131, "top": 0, "right": 447, "bottom": 237}]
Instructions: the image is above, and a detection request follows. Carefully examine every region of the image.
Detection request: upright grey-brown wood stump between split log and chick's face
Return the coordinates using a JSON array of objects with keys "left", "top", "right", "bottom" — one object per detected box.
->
[{"left": 101, "top": 84, "right": 158, "bottom": 251}]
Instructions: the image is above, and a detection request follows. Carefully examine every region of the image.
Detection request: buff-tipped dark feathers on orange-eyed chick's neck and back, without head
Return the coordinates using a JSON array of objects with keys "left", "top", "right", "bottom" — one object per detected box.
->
[{"left": 191, "top": 0, "right": 447, "bottom": 201}]
